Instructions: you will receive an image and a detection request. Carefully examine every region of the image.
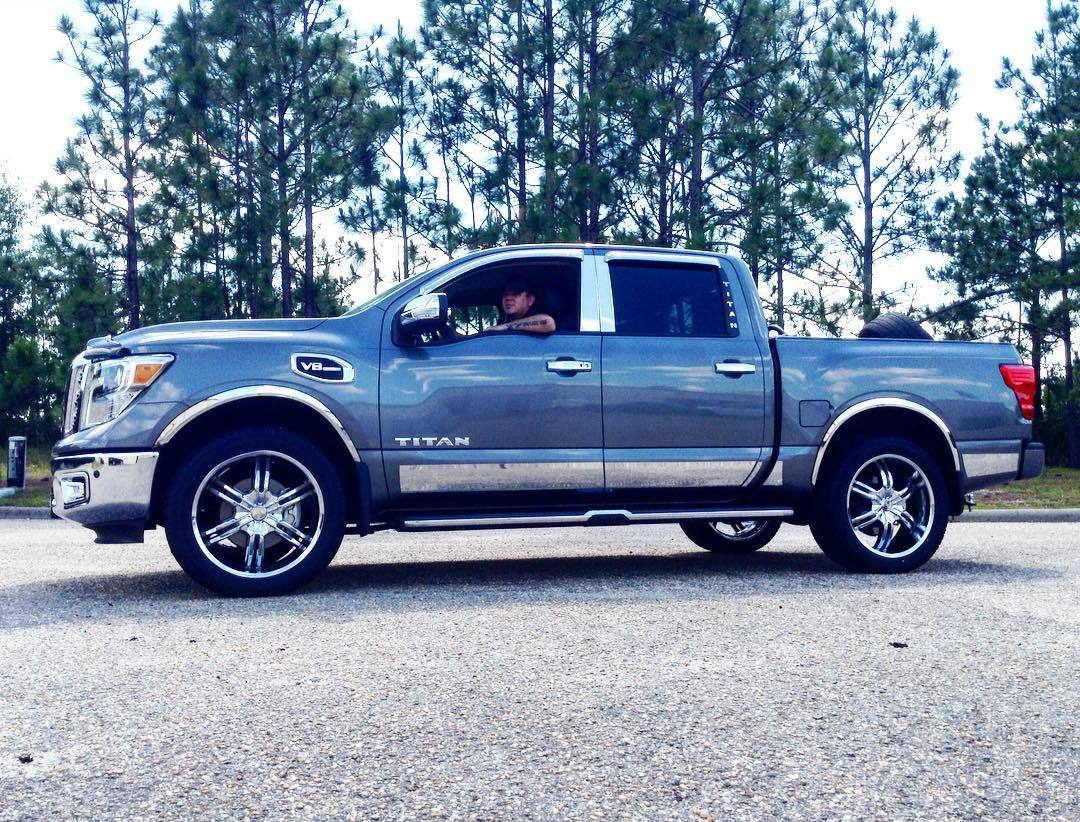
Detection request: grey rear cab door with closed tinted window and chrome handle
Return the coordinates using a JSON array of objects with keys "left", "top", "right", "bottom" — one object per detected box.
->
[{"left": 596, "top": 252, "right": 771, "bottom": 502}]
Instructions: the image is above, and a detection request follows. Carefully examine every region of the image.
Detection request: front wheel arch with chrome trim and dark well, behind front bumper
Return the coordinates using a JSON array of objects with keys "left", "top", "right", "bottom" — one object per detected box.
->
[{"left": 150, "top": 386, "right": 370, "bottom": 529}]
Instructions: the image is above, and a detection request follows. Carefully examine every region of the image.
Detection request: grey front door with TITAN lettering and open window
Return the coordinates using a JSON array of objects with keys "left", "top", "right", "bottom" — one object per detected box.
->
[{"left": 379, "top": 250, "right": 604, "bottom": 511}]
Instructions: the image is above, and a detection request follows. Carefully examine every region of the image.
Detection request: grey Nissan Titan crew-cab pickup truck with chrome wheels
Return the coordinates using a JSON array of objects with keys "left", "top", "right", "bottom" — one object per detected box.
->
[{"left": 53, "top": 240, "right": 1043, "bottom": 595}]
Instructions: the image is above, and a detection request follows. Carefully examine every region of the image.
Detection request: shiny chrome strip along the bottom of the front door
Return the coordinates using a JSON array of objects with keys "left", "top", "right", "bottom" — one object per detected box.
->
[{"left": 397, "top": 461, "right": 604, "bottom": 494}]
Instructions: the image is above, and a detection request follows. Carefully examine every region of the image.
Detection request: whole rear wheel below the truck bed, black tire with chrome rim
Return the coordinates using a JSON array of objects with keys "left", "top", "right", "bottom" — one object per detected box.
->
[{"left": 810, "top": 436, "right": 949, "bottom": 574}]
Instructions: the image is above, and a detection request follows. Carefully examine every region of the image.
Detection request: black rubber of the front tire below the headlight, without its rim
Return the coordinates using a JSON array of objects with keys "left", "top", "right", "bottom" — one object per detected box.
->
[{"left": 164, "top": 427, "right": 346, "bottom": 596}]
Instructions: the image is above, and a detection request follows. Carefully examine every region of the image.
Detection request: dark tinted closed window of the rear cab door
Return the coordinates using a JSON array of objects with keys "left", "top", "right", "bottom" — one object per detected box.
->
[{"left": 608, "top": 261, "right": 739, "bottom": 337}]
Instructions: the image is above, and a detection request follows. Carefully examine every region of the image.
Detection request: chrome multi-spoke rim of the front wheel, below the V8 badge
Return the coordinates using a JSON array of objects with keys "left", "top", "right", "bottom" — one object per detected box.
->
[{"left": 191, "top": 450, "right": 325, "bottom": 578}]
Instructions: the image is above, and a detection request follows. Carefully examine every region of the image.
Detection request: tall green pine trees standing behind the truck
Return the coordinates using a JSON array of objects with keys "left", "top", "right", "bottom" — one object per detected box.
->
[{"left": 0, "top": 0, "right": 1080, "bottom": 467}]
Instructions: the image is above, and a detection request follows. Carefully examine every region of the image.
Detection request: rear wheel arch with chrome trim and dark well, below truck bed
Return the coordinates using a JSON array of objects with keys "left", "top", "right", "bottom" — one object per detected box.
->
[{"left": 810, "top": 397, "right": 963, "bottom": 514}]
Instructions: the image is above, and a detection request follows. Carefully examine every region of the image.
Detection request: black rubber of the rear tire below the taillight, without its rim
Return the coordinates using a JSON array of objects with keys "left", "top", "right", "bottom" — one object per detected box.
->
[{"left": 810, "top": 436, "right": 949, "bottom": 574}]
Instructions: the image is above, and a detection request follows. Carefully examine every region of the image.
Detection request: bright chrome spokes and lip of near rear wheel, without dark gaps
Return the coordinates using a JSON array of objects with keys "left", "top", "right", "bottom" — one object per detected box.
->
[{"left": 846, "top": 454, "right": 935, "bottom": 560}]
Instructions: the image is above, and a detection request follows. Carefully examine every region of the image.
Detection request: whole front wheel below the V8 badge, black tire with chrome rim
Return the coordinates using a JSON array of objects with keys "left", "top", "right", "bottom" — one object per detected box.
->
[{"left": 164, "top": 428, "right": 346, "bottom": 596}]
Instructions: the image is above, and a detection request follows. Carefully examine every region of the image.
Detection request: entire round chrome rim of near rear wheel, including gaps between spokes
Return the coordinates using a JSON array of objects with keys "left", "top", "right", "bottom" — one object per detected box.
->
[{"left": 848, "top": 454, "right": 934, "bottom": 560}]
